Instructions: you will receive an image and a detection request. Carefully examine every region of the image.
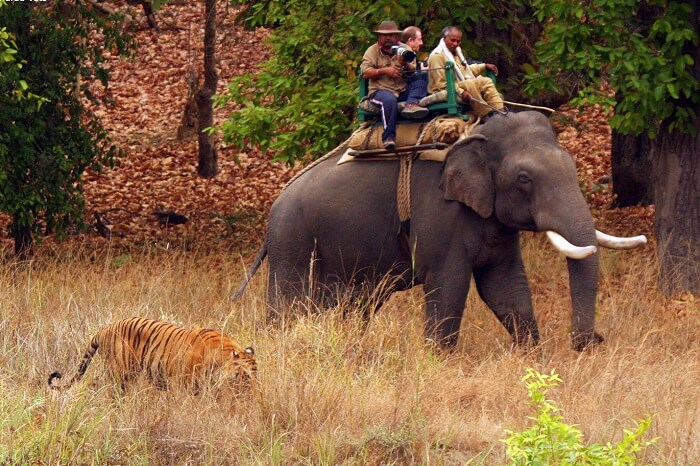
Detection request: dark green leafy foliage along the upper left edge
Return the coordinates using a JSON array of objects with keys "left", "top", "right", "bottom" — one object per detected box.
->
[{"left": 0, "top": 2, "right": 130, "bottom": 253}]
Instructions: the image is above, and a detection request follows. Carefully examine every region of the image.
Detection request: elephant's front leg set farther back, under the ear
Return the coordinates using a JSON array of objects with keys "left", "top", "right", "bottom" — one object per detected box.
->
[{"left": 423, "top": 263, "right": 471, "bottom": 348}]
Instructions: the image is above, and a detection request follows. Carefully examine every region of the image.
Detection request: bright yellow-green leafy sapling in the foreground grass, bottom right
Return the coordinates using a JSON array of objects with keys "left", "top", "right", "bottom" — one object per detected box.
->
[{"left": 503, "top": 369, "right": 656, "bottom": 466}]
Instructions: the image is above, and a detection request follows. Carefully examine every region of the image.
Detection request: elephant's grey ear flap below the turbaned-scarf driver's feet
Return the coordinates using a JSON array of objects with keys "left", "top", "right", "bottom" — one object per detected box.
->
[{"left": 443, "top": 149, "right": 495, "bottom": 218}]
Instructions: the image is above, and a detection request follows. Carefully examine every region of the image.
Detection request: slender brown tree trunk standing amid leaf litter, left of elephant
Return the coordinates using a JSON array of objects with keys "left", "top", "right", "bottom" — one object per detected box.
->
[{"left": 197, "top": 0, "right": 219, "bottom": 178}]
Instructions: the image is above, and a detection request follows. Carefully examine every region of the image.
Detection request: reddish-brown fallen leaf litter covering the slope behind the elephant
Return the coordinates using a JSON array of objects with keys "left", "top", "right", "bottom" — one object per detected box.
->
[{"left": 2, "top": 1, "right": 653, "bottom": 255}]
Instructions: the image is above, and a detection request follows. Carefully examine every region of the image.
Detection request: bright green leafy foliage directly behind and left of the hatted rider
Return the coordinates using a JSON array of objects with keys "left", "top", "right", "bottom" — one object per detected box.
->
[{"left": 216, "top": 0, "right": 387, "bottom": 163}]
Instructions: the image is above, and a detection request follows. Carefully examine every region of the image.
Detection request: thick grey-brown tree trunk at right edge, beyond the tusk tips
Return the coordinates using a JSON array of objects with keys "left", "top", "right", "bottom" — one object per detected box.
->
[{"left": 651, "top": 119, "right": 700, "bottom": 296}]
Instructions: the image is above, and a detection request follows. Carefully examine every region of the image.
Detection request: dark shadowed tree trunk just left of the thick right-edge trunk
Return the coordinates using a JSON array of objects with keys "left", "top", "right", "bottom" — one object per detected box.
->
[{"left": 612, "top": 130, "right": 654, "bottom": 207}]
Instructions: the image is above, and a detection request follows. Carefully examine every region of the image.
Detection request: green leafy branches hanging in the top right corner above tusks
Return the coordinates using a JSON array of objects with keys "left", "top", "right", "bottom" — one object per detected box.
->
[{"left": 526, "top": 0, "right": 700, "bottom": 138}]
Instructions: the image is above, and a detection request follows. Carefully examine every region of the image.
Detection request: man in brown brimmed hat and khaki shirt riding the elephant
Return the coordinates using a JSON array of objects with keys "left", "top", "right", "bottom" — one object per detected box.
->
[{"left": 360, "top": 21, "right": 428, "bottom": 149}]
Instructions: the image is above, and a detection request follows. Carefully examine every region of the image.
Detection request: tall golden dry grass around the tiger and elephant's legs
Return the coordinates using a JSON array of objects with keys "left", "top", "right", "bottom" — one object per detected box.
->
[{"left": 0, "top": 235, "right": 700, "bottom": 465}]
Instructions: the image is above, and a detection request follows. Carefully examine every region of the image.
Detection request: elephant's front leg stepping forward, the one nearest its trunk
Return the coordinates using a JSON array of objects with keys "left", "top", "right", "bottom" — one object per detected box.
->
[{"left": 474, "top": 255, "right": 540, "bottom": 345}]
